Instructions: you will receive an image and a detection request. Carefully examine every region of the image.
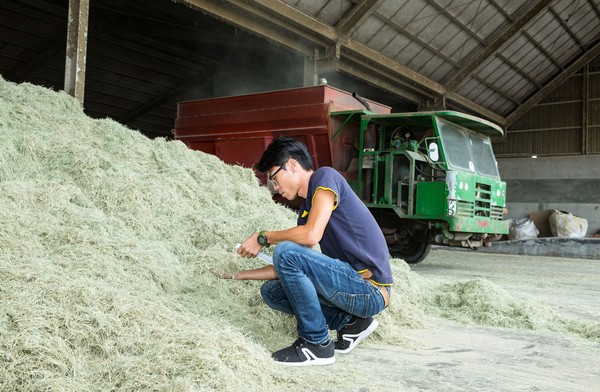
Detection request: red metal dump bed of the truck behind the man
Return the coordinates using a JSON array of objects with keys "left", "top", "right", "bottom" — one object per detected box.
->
[{"left": 173, "top": 85, "right": 391, "bottom": 184}]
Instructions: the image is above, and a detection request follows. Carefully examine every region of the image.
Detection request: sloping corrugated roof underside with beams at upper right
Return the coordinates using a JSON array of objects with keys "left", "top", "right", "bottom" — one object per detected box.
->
[{"left": 221, "top": 0, "right": 600, "bottom": 123}]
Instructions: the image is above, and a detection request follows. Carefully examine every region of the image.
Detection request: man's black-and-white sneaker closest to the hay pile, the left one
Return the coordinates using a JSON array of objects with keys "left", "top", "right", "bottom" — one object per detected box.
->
[{"left": 271, "top": 338, "right": 335, "bottom": 366}]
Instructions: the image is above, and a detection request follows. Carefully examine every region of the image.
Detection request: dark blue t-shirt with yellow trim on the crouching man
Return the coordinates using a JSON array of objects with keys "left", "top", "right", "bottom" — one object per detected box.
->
[{"left": 298, "top": 167, "right": 393, "bottom": 285}]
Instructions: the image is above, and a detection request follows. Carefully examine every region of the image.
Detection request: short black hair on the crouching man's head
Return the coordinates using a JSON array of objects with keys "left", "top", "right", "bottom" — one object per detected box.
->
[{"left": 256, "top": 137, "right": 313, "bottom": 173}]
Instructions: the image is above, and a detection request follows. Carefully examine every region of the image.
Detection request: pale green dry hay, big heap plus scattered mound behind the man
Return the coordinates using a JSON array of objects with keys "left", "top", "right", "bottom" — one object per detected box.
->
[{"left": 0, "top": 77, "right": 598, "bottom": 391}]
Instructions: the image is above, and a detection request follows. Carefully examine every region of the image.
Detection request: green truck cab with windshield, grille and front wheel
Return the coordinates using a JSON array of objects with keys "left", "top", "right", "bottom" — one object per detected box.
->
[{"left": 330, "top": 110, "right": 508, "bottom": 263}]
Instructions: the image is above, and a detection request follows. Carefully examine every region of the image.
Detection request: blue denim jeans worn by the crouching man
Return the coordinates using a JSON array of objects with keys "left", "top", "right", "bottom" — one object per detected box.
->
[{"left": 260, "top": 242, "right": 385, "bottom": 344}]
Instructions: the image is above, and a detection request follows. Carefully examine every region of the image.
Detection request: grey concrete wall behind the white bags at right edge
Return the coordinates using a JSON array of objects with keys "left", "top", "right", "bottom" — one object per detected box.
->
[{"left": 498, "top": 155, "right": 600, "bottom": 236}]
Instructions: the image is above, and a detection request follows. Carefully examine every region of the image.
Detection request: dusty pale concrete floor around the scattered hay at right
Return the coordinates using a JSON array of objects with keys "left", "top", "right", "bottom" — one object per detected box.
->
[{"left": 294, "top": 250, "right": 600, "bottom": 392}]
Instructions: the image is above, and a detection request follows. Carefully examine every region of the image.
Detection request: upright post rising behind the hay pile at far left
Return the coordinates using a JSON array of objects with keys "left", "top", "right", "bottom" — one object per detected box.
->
[{"left": 65, "top": 0, "right": 90, "bottom": 106}]
